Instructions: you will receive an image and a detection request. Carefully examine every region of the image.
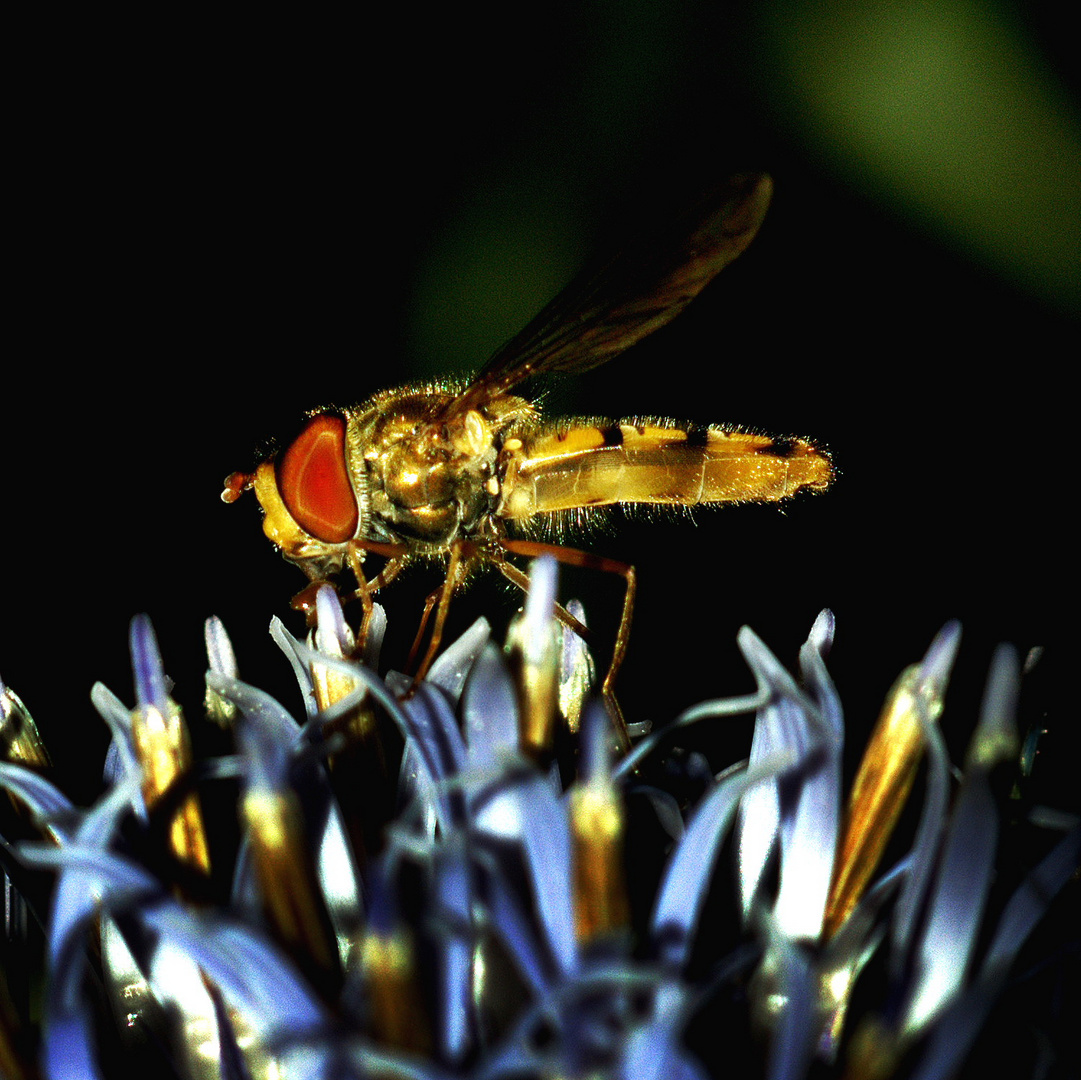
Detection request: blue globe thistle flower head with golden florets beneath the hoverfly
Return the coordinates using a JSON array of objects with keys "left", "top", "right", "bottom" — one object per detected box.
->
[{"left": 0, "top": 559, "right": 1081, "bottom": 1080}]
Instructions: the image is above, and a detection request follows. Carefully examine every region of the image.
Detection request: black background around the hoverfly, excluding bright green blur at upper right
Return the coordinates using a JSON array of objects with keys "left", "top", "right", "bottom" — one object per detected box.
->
[{"left": 0, "top": 4, "right": 1079, "bottom": 817}]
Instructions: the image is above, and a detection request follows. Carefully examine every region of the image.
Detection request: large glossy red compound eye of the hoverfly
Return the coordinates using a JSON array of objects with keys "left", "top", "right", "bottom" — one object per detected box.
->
[{"left": 278, "top": 415, "right": 358, "bottom": 544}]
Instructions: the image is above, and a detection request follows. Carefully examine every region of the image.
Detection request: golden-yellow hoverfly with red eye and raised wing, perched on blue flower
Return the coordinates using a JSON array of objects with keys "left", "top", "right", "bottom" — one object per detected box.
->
[{"left": 222, "top": 175, "right": 832, "bottom": 735}]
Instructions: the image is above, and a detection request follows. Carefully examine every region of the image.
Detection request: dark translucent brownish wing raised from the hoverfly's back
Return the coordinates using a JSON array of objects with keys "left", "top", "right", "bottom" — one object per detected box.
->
[{"left": 452, "top": 174, "right": 773, "bottom": 412}]
